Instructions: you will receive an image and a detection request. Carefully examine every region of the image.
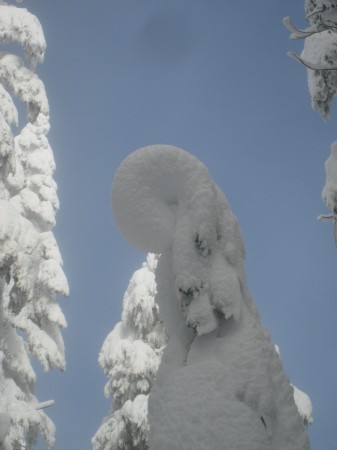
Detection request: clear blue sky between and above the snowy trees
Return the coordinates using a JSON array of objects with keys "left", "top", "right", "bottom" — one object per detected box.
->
[{"left": 23, "top": 0, "right": 337, "bottom": 450}]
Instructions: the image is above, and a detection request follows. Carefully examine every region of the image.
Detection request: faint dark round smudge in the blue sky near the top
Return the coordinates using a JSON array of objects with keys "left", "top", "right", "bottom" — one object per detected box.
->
[{"left": 136, "top": 9, "right": 196, "bottom": 63}]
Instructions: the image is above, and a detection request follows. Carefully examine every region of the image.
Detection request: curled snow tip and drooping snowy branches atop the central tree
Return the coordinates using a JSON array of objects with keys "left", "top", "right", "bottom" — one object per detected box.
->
[{"left": 112, "top": 145, "right": 244, "bottom": 334}]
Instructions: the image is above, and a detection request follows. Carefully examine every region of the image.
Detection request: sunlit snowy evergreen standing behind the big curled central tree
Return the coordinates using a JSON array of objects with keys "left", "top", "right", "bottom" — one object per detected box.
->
[{"left": 92, "top": 254, "right": 166, "bottom": 450}]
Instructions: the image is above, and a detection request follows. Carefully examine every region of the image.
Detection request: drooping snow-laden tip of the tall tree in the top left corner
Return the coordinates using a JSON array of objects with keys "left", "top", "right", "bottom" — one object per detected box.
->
[{"left": 0, "top": 4, "right": 46, "bottom": 68}]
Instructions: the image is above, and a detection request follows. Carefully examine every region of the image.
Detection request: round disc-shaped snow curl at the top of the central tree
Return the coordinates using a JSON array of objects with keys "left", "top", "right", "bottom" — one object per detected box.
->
[{"left": 112, "top": 144, "right": 214, "bottom": 253}]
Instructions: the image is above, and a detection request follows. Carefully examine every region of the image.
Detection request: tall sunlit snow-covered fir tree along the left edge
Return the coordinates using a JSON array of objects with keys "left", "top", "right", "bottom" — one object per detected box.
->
[{"left": 0, "top": 1, "right": 68, "bottom": 450}]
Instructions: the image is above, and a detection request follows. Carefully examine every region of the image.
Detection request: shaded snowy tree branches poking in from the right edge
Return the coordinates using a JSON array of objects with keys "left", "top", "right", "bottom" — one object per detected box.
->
[{"left": 283, "top": 0, "right": 337, "bottom": 246}]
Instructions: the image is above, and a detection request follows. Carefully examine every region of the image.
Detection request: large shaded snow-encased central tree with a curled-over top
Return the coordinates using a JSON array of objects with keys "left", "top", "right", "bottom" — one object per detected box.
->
[{"left": 112, "top": 145, "right": 309, "bottom": 450}]
